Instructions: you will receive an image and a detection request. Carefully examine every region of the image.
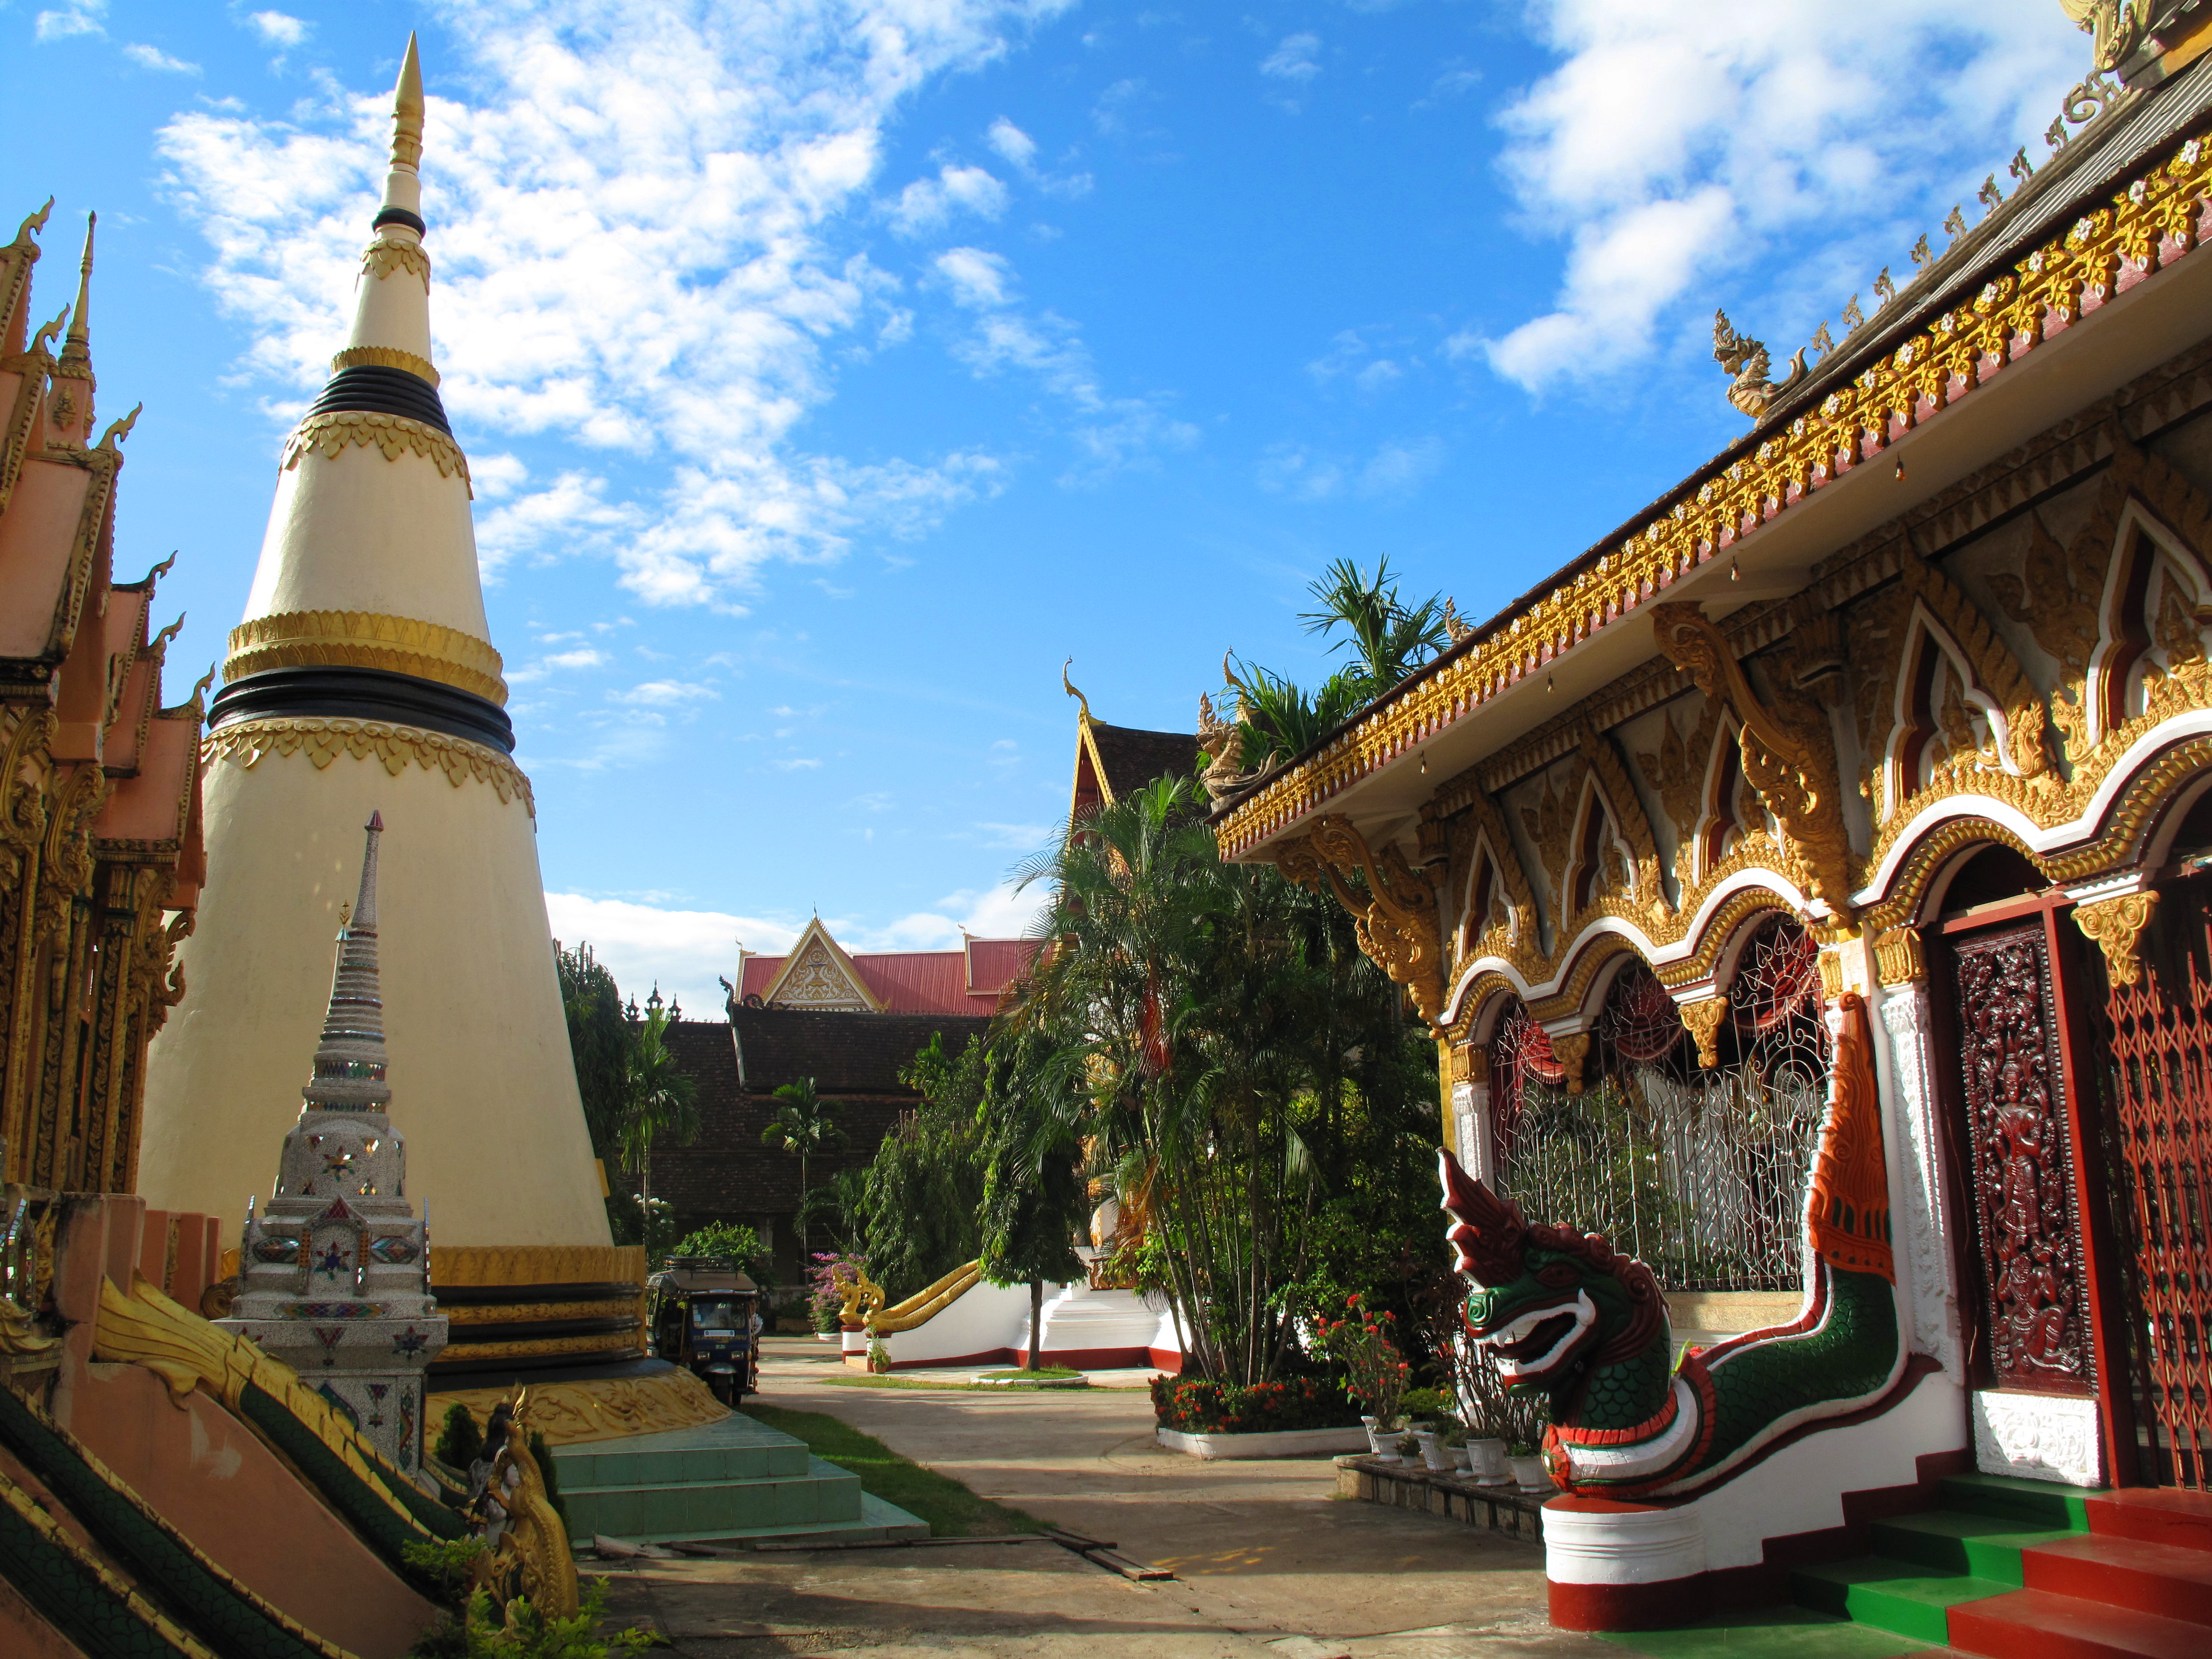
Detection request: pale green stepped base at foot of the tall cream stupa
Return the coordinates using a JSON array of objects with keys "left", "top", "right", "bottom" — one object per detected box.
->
[{"left": 553, "top": 1416, "right": 929, "bottom": 1544}]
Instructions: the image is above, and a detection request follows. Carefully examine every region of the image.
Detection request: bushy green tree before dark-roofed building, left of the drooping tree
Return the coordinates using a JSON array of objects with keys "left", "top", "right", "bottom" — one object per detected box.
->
[{"left": 856, "top": 1031, "right": 989, "bottom": 1301}]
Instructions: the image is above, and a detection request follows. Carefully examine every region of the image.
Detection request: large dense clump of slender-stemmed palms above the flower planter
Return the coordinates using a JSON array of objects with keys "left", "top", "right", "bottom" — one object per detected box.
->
[{"left": 1000, "top": 778, "right": 1440, "bottom": 1385}]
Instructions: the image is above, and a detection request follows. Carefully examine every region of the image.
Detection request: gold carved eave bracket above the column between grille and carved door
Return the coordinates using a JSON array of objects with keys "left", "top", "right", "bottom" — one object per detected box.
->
[{"left": 1652, "top": 602, "right": 1854, "bottom": 922}]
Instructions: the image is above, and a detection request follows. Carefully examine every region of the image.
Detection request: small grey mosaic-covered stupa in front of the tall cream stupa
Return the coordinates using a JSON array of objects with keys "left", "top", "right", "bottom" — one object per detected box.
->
[{"left": 219, "top": 814, "right": 447, "bottom": 1473}]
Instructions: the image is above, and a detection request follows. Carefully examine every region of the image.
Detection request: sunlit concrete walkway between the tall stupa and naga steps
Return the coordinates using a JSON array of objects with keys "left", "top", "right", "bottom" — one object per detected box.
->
[{"left": 597, "top": 1338, "right": 1621, "bottom": 1659}]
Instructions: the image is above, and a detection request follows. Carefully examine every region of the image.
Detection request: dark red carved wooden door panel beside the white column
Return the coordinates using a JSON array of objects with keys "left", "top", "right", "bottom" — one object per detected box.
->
[{"left": 1951, "top": 916, "right": 2097, "bottom": 1396}]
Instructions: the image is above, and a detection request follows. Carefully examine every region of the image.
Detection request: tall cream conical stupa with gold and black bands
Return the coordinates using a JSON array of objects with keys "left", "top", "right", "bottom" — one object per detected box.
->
[{"left": 142, "top": 49, "right": 644, "bottom": 1385}]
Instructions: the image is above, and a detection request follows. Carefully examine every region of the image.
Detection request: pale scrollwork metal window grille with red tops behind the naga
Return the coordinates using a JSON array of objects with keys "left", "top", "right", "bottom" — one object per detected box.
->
[{"left": 1491, "top": 916, "right": 1829, "bottom": 1290}]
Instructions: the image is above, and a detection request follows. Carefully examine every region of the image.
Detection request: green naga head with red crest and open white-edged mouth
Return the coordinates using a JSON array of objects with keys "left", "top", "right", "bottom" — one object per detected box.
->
[{"left": 1438, "top": 1148, "right": 1668, "bottom": 1422}]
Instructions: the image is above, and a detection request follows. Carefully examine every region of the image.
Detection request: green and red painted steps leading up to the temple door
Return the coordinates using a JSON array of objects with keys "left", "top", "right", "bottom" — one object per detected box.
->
[{"left": 1792, "top": 1475, "right": 2212, "bottom": 1659}]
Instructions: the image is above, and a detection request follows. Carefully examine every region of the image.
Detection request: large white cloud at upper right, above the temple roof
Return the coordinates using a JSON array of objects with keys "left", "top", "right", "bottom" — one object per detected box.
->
[{"left": 1486, "top": 0, "right": 2088, "bottom": 389}]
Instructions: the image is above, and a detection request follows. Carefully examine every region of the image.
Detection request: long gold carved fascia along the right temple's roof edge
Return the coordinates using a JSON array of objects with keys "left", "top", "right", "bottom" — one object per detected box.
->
[{"left": 1217, "top": 123, "right": 2212, "bottom": 863}]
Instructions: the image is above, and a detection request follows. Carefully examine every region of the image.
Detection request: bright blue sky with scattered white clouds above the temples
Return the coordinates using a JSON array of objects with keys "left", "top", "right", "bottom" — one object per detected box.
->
[{"left": 13, "top": 0, "right": 2086, "bottom": 1013}]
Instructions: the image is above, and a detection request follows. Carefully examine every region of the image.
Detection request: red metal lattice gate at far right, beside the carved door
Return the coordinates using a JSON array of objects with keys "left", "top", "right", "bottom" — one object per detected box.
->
[{"left": 2106, "top": 898, "right": 2212, "bottom": 1491}]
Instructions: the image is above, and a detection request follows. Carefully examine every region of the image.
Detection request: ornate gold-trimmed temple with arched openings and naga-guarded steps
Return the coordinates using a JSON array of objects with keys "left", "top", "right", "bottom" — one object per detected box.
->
[{"left": 1214, "top": 0, "right": 2212, "bottom": 1654}]
